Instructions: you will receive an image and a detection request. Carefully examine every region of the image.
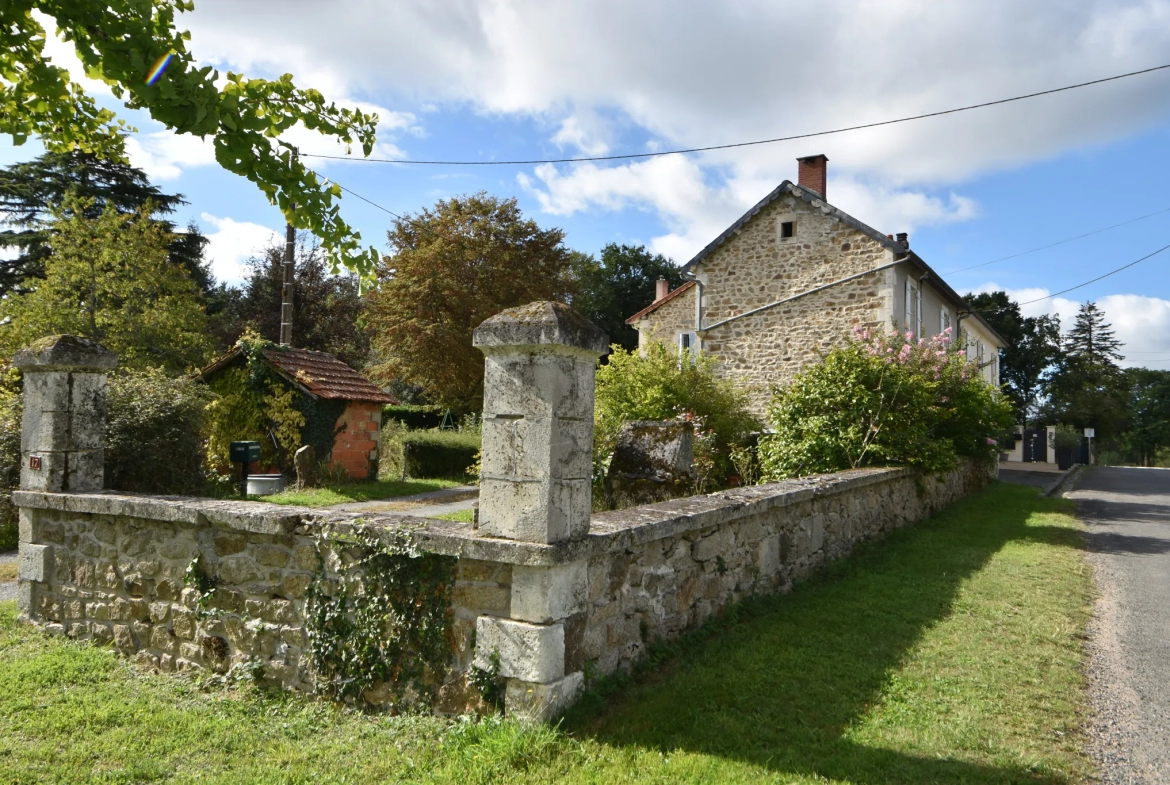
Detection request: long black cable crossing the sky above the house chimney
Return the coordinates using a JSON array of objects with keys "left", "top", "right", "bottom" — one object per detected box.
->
[{"left": 301, "top": 63, "right": 1170, "bottom": 166}]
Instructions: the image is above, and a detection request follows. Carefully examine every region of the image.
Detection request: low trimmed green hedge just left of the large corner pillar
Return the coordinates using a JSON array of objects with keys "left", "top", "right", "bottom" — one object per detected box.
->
[{"left": 378, "top": 420, "right": 480, "bottom": 480}]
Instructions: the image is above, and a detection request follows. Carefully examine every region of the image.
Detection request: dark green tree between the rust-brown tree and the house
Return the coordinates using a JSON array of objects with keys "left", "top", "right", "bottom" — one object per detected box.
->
[{"left": 572, "top": 243, "right": 684, "bottom": 350}]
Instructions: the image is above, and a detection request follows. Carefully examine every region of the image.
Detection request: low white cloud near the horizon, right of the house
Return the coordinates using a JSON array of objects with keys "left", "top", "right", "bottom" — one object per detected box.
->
[{"left": 971, "top": 283, "right": 1170, "bottom": 370}]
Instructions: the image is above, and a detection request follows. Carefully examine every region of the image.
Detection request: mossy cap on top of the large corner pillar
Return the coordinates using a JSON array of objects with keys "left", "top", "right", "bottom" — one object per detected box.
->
[{"left": 472, "top": 301, "right": 610, "bottom": 354}]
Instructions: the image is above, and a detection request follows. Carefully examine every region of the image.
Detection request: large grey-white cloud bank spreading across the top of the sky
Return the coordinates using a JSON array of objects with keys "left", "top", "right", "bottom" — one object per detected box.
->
[{"left": 177, "top": 0, "right": 1170, "bottom": 185}]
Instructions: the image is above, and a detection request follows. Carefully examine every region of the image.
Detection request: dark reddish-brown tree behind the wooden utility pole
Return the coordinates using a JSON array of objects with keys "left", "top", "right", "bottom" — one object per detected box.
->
[{"left": 208, "top": 233, "right": 370, "bottom": 369}]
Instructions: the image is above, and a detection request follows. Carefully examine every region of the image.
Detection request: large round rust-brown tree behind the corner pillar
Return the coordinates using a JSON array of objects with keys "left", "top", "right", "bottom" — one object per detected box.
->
[{"left": 366, "top": 193, "right": 571, "bottom": 412}]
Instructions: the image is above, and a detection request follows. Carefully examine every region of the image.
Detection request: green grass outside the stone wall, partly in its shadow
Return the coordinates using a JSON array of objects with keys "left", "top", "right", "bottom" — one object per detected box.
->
[{"left": 0, "top": 484, "right": 1090, "bottom": 785}]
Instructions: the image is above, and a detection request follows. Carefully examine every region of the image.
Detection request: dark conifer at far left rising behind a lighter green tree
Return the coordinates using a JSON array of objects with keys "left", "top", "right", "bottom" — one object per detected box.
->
[{"left": 0, "top": 150, "right": 213, "bottom": 296}]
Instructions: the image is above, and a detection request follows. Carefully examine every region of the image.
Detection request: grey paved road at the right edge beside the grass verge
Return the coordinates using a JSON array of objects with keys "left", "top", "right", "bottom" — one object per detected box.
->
[{"left": 1066, "top": 468, "right": 1170, "bottom": 785}]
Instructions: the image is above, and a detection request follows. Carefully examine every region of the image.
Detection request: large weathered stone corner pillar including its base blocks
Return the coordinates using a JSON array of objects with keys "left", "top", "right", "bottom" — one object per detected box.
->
[{"left": 473, "top": 302, "right": 608, "bottom": 719}]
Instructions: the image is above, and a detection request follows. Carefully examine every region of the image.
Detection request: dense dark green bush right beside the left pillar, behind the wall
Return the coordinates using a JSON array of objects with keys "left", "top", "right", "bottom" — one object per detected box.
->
[{"left": 105, "top": 371, "right": 212, "bottom": 496}]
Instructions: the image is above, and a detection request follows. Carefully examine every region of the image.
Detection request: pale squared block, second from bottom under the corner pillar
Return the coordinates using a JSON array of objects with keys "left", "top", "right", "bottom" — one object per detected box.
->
[{"left": 474, "top": 617, "right": 565, "bottom": 684}]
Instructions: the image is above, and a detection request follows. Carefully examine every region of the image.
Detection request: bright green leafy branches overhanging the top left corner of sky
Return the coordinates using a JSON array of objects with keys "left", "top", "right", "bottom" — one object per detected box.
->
[{"left": 0, "top": 0, "right": 378, "bottom": 274}]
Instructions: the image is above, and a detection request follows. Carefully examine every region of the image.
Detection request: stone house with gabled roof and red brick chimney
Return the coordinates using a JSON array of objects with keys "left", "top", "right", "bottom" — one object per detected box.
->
[{"left": 626, "top": 150, "right": 1005, "bottom": 414}]
